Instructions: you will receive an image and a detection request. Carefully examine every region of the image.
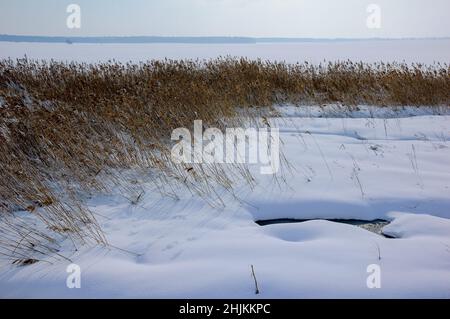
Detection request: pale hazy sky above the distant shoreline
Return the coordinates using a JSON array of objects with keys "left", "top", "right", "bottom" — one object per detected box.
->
[{"left": 0, "top": 0, "right": 450, "bottom": 38}]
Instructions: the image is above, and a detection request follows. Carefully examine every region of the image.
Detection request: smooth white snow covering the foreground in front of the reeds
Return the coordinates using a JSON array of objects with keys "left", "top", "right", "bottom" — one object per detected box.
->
[{"left": 0, "top": 106, "right": 450, "bottom": 298}]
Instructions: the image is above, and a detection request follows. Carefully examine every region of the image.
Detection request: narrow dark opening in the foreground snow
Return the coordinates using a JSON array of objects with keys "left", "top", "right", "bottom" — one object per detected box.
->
[{"left": 256, "top": 218, "right": 393, "bottom": 238}]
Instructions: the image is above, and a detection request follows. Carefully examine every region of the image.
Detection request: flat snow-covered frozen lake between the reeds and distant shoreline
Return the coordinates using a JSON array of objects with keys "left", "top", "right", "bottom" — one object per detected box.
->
[{"left": 0, "top": 39, "right": 450, "bottom": 64}]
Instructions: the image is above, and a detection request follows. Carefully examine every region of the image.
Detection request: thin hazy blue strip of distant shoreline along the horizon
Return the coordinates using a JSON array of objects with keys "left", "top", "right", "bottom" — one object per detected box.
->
[{"left": 0, "top": 34, "right": 450, "bottom": 44}]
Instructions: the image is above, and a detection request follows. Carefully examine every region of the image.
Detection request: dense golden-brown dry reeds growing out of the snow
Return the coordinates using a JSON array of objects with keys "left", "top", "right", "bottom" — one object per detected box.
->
[{"left": 0, "top": 58, "right": 450, "bottom": 264}]
